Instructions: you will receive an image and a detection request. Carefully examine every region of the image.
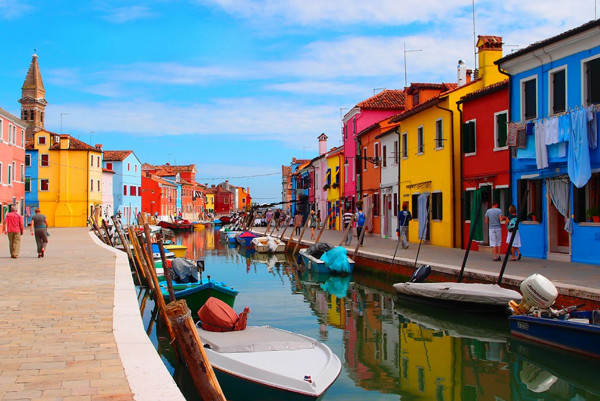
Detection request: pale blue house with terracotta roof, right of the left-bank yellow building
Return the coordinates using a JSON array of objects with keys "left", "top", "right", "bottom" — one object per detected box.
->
[{"left": 102, "top": 150, "right": 142, "bottom": 223}]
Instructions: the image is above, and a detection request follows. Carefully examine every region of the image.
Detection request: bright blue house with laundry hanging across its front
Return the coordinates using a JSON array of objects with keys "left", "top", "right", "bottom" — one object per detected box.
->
[{"left": 496, "top": 20, "right": 600, "bottom": 264}]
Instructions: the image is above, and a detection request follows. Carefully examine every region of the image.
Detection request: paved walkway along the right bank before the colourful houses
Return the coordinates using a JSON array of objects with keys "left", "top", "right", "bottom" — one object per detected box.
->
[{"left": 253, "top": 227, "right": 600, "bottom": 303}]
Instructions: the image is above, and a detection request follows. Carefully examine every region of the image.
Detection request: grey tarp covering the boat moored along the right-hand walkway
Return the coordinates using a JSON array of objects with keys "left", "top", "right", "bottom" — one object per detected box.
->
[{"left": 394, "top": 282, "right": 522, "bottom": 305}]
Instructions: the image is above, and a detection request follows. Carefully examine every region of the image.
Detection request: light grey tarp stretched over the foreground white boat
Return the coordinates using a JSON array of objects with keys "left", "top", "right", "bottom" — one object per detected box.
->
[{"left": 198, "top": 326, "right": 316, "bottom": 353}]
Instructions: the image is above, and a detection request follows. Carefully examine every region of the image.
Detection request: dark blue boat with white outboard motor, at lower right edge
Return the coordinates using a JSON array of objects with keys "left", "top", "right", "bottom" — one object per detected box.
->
[{"left": 508, "top": 310, "right": 600, "bottom": 358}]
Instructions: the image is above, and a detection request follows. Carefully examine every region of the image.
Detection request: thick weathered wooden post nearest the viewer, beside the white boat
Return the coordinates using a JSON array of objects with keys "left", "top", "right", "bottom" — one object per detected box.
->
[{"left": 166, "top": 300, "right": 226, "bottom": 401}]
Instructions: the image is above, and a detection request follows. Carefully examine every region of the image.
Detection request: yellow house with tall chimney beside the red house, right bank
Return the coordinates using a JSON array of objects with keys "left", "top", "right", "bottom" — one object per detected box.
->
[{"left": 391, "top": 36, "right": 506, "bottom": 247}]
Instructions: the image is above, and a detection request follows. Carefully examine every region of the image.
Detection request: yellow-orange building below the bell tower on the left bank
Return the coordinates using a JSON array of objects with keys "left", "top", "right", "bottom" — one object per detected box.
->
[{"left": 32, "top": 130, "right": 102, "bottom": 227}]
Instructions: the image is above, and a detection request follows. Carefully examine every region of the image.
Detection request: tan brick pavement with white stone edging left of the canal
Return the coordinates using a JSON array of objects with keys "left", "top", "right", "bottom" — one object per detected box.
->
[{"left": 0, "top": 228, "right": 184, "bottom": 401}]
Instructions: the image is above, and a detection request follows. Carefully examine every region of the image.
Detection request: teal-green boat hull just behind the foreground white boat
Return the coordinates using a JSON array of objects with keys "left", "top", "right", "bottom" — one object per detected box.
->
[{"left": 160, "top": 280, "right": 238, "bottom": 316}]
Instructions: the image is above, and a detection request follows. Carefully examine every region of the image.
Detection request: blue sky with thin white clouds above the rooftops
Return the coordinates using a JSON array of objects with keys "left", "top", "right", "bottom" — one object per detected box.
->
[{"left": 0, "top": 0, "right": 600, "bottom": 202}]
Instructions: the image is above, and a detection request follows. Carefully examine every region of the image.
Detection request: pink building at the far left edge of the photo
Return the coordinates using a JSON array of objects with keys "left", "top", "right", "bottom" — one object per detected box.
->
[{"left": 0, "top": 108, "right": 27, "bottom": 221}]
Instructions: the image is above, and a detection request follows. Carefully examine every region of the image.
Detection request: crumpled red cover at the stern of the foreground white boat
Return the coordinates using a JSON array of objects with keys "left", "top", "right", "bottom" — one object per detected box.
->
[{"left": 198, "top": 297, "right": 250, "bottom": 332}]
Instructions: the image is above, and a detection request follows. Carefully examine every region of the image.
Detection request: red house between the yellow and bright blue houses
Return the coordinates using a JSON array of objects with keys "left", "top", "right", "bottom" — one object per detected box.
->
[{"left": 459, "top": 80, "right": 515, "bottom": 252}]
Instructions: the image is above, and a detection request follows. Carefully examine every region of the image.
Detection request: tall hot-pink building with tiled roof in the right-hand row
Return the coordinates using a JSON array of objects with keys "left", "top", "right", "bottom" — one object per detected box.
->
[{"left": 342, "top": 89, "right": 405, "bottom": 210}]
